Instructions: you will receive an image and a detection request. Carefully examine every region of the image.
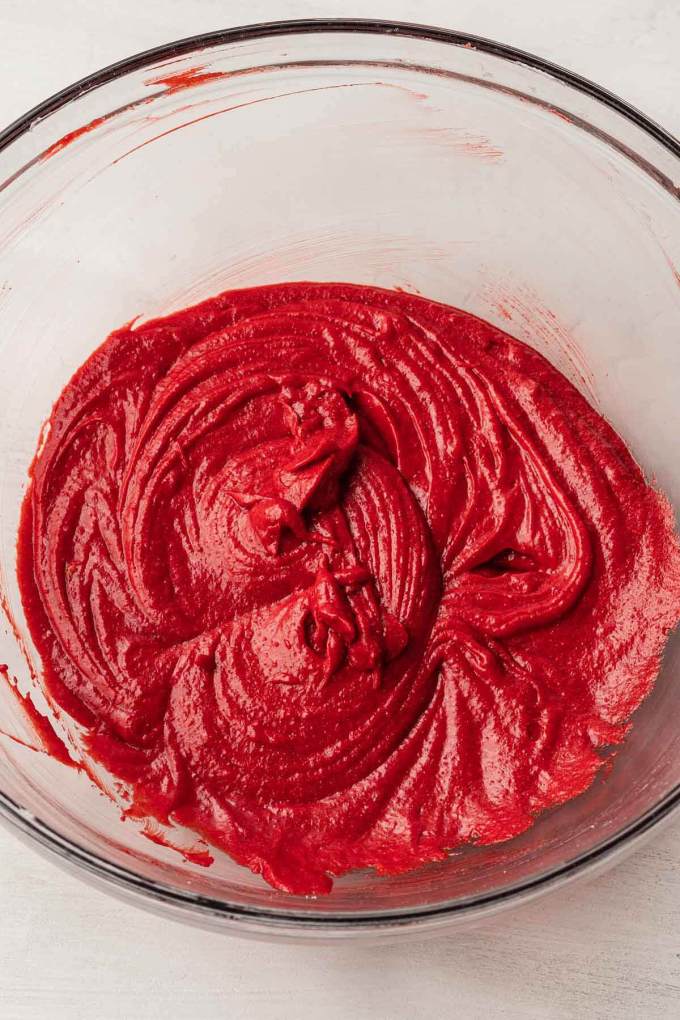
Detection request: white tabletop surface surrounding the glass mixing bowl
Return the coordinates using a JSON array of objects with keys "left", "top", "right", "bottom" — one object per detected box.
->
[{"left": 0, "top": 0, "right": 680, "bottom": 1020}]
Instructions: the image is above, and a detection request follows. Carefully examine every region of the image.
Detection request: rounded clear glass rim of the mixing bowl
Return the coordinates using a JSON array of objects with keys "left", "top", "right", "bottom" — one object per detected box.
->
[{"left": 0, "top": 18, "right": 680, "bottom": 933}]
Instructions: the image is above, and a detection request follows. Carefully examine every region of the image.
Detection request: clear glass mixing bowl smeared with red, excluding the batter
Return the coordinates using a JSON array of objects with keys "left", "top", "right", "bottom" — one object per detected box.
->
[{"left": 0, "top": 21, "right": 680, "bottom": 938}]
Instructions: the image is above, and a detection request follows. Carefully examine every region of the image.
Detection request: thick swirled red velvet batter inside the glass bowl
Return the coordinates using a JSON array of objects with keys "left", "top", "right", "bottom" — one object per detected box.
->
[{"left": 18, "top": 284, "right": 680, "bottom": 894}]
